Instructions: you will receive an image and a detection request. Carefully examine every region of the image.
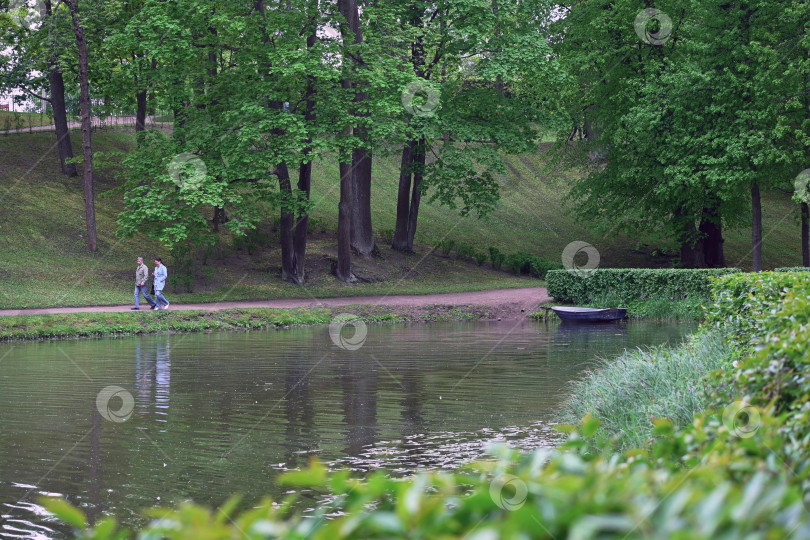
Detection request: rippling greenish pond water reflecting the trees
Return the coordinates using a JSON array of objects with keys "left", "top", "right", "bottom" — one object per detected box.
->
[{"left": 0, "top": 321, "right": 694, "bottom": 538}]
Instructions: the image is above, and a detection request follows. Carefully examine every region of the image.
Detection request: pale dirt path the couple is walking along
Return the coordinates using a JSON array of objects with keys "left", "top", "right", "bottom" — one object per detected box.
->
[{"left": 0, "top": 287, "right": 551, "bottom": 319}]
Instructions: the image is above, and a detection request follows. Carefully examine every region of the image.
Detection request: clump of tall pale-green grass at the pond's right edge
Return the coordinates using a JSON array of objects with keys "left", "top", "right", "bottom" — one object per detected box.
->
[{"left": 560, "top": 332, "right": 739, "bottom": 450}]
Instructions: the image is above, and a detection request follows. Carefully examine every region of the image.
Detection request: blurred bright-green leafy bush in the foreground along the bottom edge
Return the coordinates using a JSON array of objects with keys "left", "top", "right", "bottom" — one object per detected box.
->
[{"left": 43, "top": 426, "right": 810, "bottom": 540}]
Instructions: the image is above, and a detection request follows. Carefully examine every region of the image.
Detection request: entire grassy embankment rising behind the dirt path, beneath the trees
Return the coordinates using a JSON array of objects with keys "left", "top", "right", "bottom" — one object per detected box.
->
[{"left": 0, "top": 127, "right": 799, "bottom": 316}]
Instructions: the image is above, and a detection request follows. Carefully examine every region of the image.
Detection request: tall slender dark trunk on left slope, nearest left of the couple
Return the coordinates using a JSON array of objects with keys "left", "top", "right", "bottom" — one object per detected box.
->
[{"left": 65, "top": 0, "right": 98, "bottom": 251}]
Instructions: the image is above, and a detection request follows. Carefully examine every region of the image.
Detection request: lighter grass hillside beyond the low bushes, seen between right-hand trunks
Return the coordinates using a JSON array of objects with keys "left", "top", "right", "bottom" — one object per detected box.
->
[{"left": 313, "top": 143, "right": 801, "bottom": 269}]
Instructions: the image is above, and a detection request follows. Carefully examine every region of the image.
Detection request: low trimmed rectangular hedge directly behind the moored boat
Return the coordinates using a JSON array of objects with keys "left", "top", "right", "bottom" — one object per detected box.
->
[{"left": 546, "top": 268, "right": 740, "bottom": 304}]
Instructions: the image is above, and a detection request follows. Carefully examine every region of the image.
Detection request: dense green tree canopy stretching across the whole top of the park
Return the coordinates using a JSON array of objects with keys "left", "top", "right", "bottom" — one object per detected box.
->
[{"left": 0, "top": 0, "right": 810, "bottom": 274}]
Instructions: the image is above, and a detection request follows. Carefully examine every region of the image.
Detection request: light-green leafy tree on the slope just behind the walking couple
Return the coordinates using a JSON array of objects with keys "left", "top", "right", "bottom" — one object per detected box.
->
[{"left": 119, "top": 0, "right": 340, "bottom": 283}]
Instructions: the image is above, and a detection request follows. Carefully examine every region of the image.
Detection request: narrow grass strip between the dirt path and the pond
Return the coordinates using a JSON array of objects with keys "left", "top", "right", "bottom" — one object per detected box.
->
[{"left": 0, "top": 305, "right": 491, "bottom": 342}]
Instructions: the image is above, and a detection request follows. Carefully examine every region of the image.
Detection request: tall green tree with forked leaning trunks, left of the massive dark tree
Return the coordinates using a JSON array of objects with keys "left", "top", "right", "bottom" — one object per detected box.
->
[{"left": 392, "top": 1, "right": 563, "bottom": 251}]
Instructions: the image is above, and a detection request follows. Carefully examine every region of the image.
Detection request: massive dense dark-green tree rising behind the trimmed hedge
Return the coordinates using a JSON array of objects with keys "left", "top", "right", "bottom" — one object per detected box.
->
[{"left": 556, "top": 0, "right": 797, "bottom": 268}]
